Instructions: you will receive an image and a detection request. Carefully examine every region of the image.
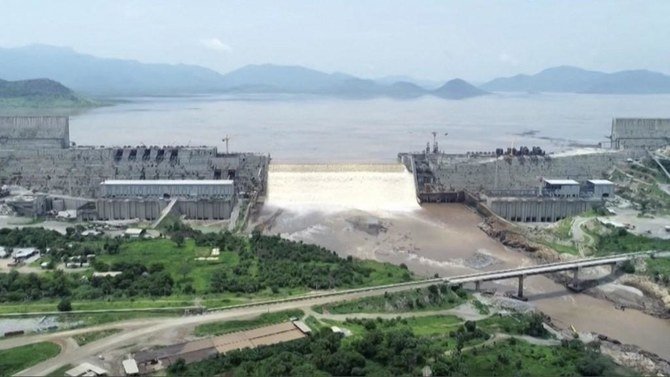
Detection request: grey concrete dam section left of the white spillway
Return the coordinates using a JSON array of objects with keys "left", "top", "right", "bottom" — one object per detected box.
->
[{"left": 0, "top": 116, "right": 270, "bottom": 220}]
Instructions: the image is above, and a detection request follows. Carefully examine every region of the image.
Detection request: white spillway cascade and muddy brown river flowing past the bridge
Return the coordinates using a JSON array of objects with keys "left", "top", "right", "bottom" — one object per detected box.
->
[{"left": 259, "top": 168, "right": 670, "bottom": 359}]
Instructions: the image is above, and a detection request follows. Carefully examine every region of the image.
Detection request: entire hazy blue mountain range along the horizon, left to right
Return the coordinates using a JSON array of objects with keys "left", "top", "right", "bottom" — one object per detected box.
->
[{"left": 0, "top": 45, "right": 670, "bottom": 99}]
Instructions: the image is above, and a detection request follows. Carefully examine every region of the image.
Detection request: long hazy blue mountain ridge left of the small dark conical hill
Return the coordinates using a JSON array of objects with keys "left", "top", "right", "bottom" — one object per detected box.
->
[{"left": 0, "top": 45, "right": 484, "bottom": 99}]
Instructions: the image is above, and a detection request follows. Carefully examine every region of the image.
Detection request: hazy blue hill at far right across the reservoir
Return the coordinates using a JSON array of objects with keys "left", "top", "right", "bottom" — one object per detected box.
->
[{"left": 481, "top": 66, "right": 670, "bottom": 94}]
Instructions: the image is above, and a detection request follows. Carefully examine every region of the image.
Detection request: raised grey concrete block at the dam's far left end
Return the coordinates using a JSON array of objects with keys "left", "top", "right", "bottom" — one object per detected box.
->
[{"left": 0, "top": 116, "right": 70, "bottom": 150}]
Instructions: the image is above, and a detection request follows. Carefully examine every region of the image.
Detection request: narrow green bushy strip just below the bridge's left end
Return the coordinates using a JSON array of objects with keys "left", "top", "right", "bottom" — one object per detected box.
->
[{"left": 314, "top": 284, "right": 468, "bottom": 314}]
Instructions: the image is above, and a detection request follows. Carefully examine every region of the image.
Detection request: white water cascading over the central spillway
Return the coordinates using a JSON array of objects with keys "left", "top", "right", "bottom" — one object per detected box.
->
[{"left": 267, "top": 164, "right": 419, "bottom": 212}]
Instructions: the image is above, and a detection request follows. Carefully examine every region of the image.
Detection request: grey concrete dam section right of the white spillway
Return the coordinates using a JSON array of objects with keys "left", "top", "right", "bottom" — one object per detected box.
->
[{"left": 398, "top": 119, "right": 670, "bottom": 221}]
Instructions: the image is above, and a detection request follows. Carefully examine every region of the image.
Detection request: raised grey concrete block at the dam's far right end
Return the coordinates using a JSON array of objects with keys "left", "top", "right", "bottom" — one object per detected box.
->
[{"left": 611, "top": 118, "right": 670, "bottom": 149}]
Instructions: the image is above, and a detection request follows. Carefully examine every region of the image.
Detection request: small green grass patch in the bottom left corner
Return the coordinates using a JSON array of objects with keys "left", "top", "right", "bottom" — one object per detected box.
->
[{"left": 0, "top": 342, "right": 60, "bottom": 377}]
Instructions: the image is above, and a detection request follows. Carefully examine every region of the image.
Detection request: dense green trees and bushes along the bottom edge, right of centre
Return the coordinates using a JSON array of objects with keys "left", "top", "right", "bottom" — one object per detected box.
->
[{"left": 177, "top": 315, "right": 631, "bottom": 376}]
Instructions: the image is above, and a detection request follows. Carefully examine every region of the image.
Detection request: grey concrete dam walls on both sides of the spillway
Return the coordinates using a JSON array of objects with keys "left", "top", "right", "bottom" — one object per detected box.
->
[{"left": 0, "top": 117, "right": 670, "bottom": 222}]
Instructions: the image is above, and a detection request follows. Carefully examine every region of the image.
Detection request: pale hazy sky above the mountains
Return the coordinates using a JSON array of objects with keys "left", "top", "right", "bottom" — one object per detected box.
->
[{"left": 0, "top": 0, "right": 670, "bottom": 81}]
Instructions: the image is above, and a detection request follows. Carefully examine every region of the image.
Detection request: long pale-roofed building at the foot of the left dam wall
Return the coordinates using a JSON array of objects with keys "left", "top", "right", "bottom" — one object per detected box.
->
[{"left": 100, "top": 179, "right": 235, "bottom": 200}]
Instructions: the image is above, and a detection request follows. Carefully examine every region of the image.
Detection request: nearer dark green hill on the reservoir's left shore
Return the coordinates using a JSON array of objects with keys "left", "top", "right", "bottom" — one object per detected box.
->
[{"left": 0, "top": 79, "right": 97, "bottom": 108}]
